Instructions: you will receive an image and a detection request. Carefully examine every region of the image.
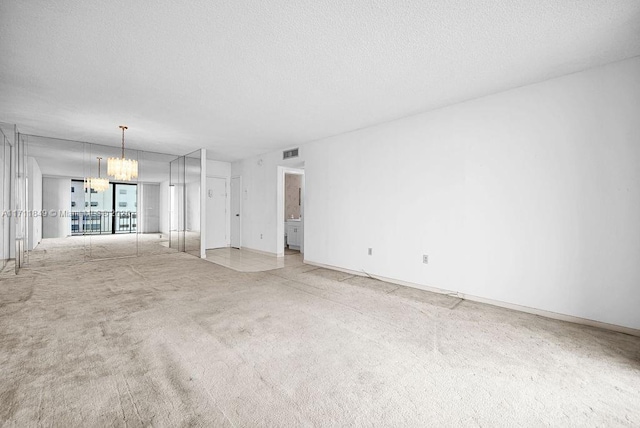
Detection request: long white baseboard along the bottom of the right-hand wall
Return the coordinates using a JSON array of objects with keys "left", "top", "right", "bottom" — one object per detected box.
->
[{"left": 304, "top": 260, "right": 640, "bottom": 337}]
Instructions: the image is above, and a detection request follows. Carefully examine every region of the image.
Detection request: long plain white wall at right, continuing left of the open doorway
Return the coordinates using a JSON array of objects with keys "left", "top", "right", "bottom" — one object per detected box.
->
[{"left": 234, "top": 58, "right": 640, "bottom": 329}]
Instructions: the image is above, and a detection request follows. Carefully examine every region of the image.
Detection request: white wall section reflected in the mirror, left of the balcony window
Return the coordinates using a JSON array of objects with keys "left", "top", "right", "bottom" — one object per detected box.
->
[{"left": 42, "top": 177, "right": 71, "bottom": 238}]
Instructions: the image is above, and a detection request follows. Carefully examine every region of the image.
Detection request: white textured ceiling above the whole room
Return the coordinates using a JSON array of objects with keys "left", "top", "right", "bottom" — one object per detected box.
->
[{"left": 0, "top": 0, "right": 640, "bottom": 160}]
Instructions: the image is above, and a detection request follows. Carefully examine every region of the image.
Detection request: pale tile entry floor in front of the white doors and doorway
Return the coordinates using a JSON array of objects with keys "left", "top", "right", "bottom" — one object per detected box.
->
[{"left": 205, "top": 248, "right": 303, "bottom": 272}]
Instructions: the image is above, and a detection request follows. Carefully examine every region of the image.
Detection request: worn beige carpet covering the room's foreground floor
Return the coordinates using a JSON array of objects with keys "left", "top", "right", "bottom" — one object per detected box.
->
[{"left": 0, "top": 242, "right": 640, "bottom": 427}]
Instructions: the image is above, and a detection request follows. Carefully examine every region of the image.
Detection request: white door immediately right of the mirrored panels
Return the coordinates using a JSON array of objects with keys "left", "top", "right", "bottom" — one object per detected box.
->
[{"left": 205, "top": 177, "right": 227, "bottom": 248}]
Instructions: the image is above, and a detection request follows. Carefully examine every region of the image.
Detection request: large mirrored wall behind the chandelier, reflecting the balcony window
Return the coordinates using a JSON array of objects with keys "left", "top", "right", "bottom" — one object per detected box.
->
[{"left": 18, "top": 135, "right": 200, "bottom": 266}]
